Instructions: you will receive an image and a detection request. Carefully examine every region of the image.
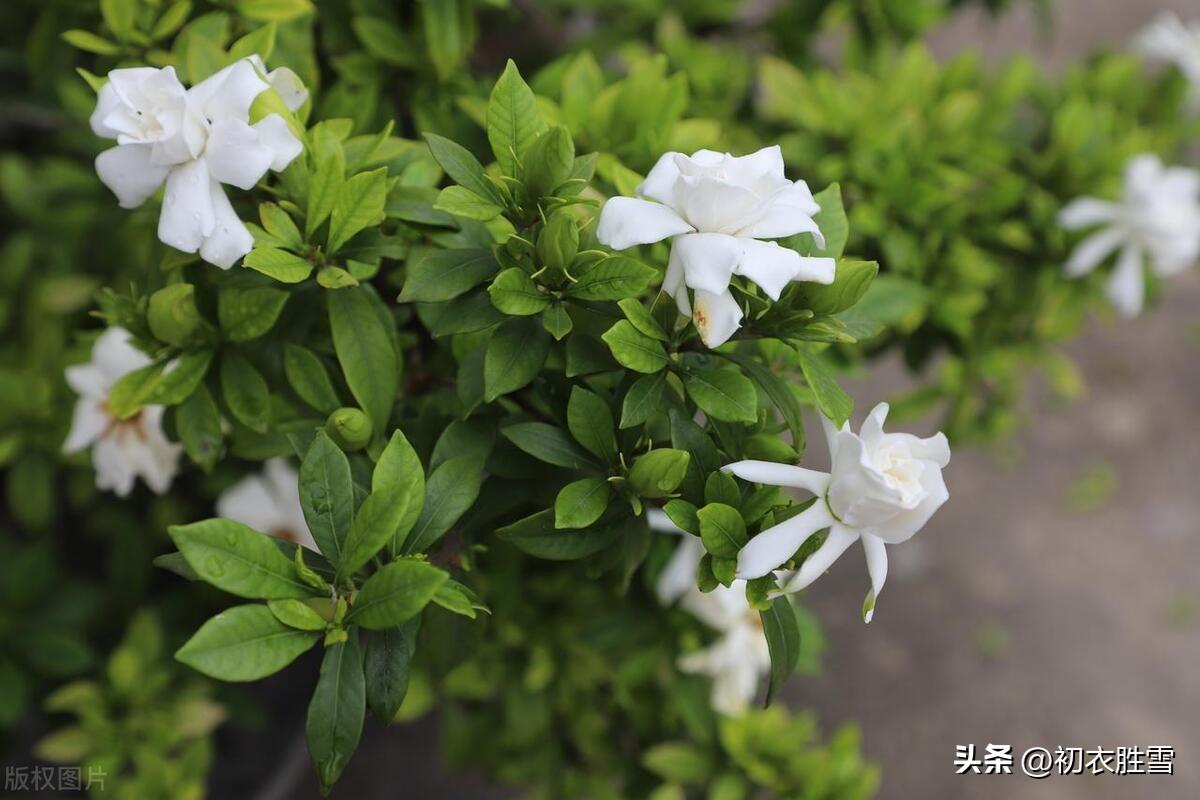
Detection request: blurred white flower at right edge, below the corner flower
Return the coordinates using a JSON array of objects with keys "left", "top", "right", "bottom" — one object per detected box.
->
[{"left": 1058, "top": 155, "right": 1200, "bottom": 317}]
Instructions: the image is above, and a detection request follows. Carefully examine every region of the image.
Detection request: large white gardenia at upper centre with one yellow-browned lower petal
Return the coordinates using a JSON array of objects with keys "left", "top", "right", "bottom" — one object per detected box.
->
[{"left": 596, "top": 145, "right": 834, "bottom": 348}]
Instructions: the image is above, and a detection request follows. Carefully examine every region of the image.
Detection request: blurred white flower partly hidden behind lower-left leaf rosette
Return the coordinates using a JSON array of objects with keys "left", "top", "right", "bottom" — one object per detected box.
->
[{"left": 217, "top": 458, "right": 319, "bottom": 553}]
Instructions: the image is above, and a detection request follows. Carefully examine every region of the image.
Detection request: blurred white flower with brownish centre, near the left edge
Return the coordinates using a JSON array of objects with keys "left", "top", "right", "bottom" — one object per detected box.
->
[{"left": 62, "top": 327, "right": 182, "bottom": 498}]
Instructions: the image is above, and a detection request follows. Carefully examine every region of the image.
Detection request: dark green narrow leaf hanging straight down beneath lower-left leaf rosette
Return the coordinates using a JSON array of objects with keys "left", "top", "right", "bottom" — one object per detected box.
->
[{"left": 305, "top": 631, "right": 366, "bottom": 793}]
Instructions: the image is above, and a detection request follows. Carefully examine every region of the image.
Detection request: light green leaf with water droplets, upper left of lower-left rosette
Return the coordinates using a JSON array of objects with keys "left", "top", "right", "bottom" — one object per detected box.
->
[{"left": 168, "top": 519, "right": 312, "bottom": 600}]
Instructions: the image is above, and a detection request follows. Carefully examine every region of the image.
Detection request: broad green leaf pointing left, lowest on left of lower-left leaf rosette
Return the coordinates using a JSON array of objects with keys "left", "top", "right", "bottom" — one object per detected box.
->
[{"left": 175, "top": 603, "right": 320, "bottom": 681}]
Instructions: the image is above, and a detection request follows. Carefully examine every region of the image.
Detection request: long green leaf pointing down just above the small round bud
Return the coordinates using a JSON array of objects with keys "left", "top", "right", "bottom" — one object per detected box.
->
[{"left": 326, "top": 287, "right": 401, "bottom": 434}]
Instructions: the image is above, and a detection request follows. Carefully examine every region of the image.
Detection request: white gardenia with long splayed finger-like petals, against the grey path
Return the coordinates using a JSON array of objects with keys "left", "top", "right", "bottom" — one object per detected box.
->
[{"left": 721, "top": 403, "right": 950, "bottom": 622}]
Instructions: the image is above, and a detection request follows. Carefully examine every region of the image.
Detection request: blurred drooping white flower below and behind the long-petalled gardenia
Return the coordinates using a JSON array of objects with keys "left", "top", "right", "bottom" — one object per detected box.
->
[{"left": 647, "top": 509, "right": 770, "bottom": 716}]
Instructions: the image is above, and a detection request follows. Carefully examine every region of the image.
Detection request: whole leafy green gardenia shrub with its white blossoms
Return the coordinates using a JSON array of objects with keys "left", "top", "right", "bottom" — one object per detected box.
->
[{"left": 0, "top": 0, "right": 1200, "bottom": 800}]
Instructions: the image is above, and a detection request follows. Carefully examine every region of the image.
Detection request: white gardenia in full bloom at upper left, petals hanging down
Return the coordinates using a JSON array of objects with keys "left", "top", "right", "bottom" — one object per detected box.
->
[{"left": 91, "top": 56, "right": 307, "bottom": 269}]
